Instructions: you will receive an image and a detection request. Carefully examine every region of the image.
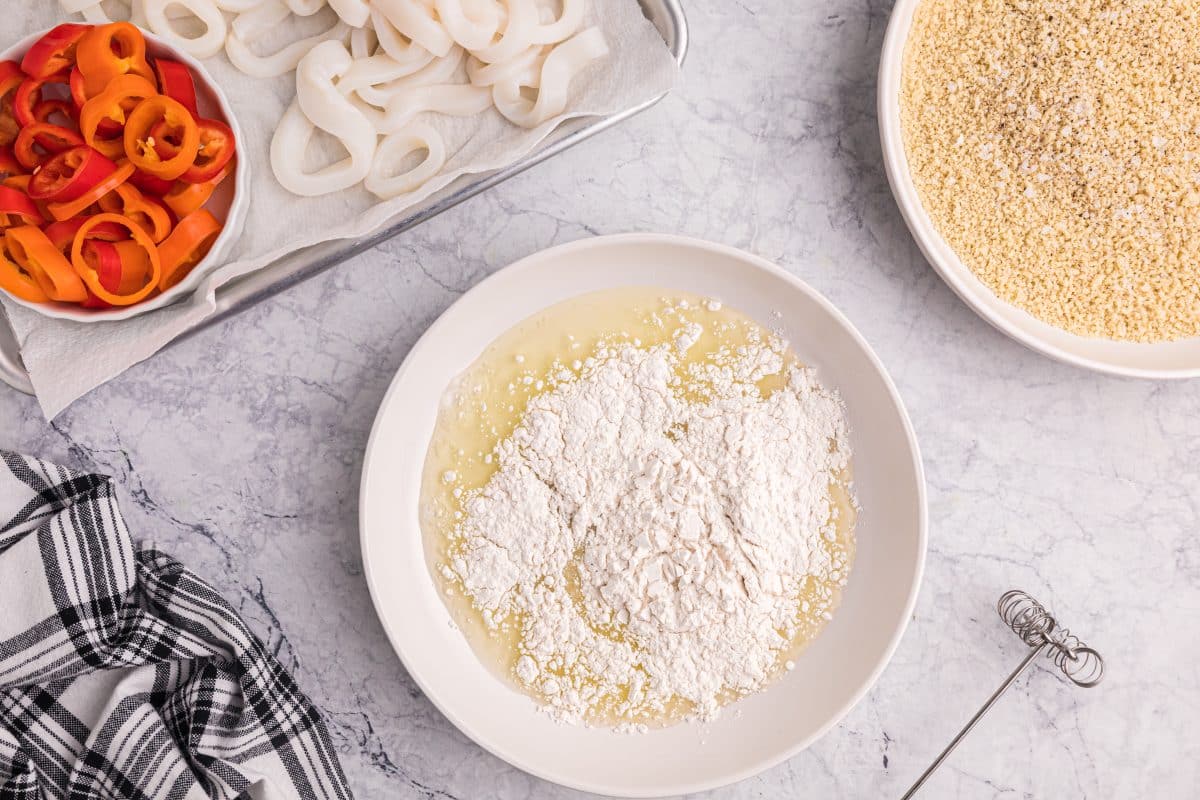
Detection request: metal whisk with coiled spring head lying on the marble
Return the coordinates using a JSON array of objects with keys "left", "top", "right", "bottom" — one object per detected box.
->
[{"left": 900, "top": 589, "right": 1104, "bottom": 800}]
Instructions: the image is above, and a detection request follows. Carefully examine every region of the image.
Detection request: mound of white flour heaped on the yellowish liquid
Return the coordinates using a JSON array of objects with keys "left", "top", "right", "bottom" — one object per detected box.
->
[{"left": 448, "top": 337, "right": 850, "bottom": 722}]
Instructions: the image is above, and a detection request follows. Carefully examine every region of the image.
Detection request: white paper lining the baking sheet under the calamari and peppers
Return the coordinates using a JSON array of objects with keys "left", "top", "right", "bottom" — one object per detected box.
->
[{"left": 0, "top": 0, "right": 678, "bottom": 419}]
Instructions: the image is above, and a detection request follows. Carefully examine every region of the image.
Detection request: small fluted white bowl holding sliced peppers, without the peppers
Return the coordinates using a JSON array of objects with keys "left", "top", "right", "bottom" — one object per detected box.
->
[{"left": 0, "top": 30, "right": 250, "bottom": 323}]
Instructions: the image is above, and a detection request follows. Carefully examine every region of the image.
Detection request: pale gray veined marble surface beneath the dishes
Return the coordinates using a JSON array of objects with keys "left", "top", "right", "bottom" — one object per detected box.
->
[{"left": 0, "top": 0, "right": 1200, "bottom": 800}]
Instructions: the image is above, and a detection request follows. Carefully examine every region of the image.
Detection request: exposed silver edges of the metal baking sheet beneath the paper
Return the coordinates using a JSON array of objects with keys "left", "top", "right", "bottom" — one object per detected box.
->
[{"left": 0, "top": 0, "right": 688, "bottom": 395}]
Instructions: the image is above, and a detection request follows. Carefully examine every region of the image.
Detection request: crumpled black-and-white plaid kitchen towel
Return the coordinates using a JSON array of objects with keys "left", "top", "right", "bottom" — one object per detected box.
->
[{"left": 0, "top": 451, "right": 350, "bottom": 800}]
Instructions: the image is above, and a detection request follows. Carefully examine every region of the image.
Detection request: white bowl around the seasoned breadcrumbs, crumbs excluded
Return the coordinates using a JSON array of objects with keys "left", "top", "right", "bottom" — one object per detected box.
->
[{"left": 878, "top": 0, "right": 1200, "bottom": 378}]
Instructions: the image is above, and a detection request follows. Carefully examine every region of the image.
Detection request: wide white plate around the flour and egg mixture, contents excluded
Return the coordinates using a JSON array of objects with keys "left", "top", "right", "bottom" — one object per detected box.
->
[{"left": 359, "top": 234, "right": 925, "bottom": 796}]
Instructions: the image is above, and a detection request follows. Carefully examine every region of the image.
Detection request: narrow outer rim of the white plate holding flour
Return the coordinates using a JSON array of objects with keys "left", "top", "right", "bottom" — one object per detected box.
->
[{"left": 359, "top": 233, "right": 929, "bottom": 798}]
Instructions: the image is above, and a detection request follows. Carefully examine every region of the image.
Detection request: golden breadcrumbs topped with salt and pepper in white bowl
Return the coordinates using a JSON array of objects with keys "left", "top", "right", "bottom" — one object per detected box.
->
[{"left": 900, "top": 0, "right": 1200, "bottom": 342}]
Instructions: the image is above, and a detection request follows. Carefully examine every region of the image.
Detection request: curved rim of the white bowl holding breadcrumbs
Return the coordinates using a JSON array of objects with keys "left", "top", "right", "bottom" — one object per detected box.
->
[{"left": 876, "top": 0, "right": 1200, "bottom": 380}]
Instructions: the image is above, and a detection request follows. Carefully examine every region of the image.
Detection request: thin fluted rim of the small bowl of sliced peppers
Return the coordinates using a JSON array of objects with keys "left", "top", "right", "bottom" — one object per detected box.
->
[{"left": 0, "top": 28, "right": 250, "bottom": 323}]
